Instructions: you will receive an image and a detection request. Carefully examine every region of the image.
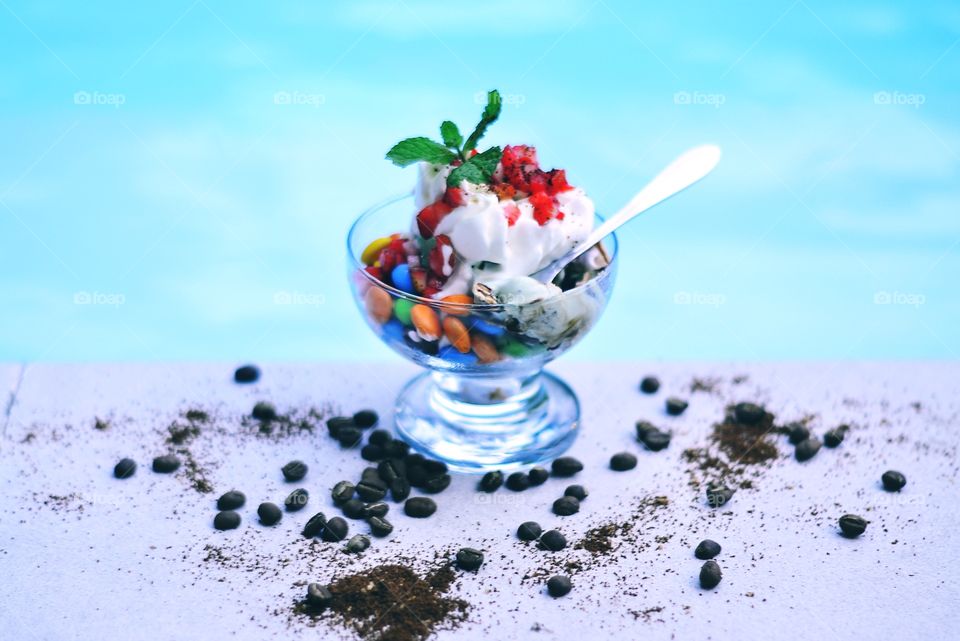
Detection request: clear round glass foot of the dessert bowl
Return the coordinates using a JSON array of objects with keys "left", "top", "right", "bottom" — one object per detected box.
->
[{"left": 396, "top": 372, "right": 580, "bottom": 472}]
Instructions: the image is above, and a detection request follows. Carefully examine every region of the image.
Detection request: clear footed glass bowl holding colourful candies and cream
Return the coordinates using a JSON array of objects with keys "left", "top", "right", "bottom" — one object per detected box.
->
[{"left": 347, "top": 194, "right": 617, "bottom": 472}]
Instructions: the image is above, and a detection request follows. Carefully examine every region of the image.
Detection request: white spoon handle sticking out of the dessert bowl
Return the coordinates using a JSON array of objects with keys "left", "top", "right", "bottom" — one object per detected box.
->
[{"left": 534, "top": 145, "right": 720, "bottom": 283}]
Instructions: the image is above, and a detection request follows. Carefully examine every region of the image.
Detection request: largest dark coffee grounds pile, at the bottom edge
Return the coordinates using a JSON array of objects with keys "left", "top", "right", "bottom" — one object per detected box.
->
[{"left": 294, "top": 564, "right": 469, "bottom": 641}]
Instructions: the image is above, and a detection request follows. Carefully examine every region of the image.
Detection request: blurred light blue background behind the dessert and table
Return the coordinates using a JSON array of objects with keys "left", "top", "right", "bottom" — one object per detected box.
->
[{"left": 0, "top": 0, "right": 960, "bottom": 360}]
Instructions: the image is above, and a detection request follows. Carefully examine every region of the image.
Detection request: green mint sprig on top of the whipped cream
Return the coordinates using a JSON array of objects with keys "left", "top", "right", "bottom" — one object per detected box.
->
[{"left": 387, "top": 89, "right": 503, "bottom": 187}]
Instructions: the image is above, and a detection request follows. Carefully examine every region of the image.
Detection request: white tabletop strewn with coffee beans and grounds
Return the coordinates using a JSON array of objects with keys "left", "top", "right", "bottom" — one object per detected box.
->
[{"left": 0, "top": 362, "right": 960, "bottom": 639}]
